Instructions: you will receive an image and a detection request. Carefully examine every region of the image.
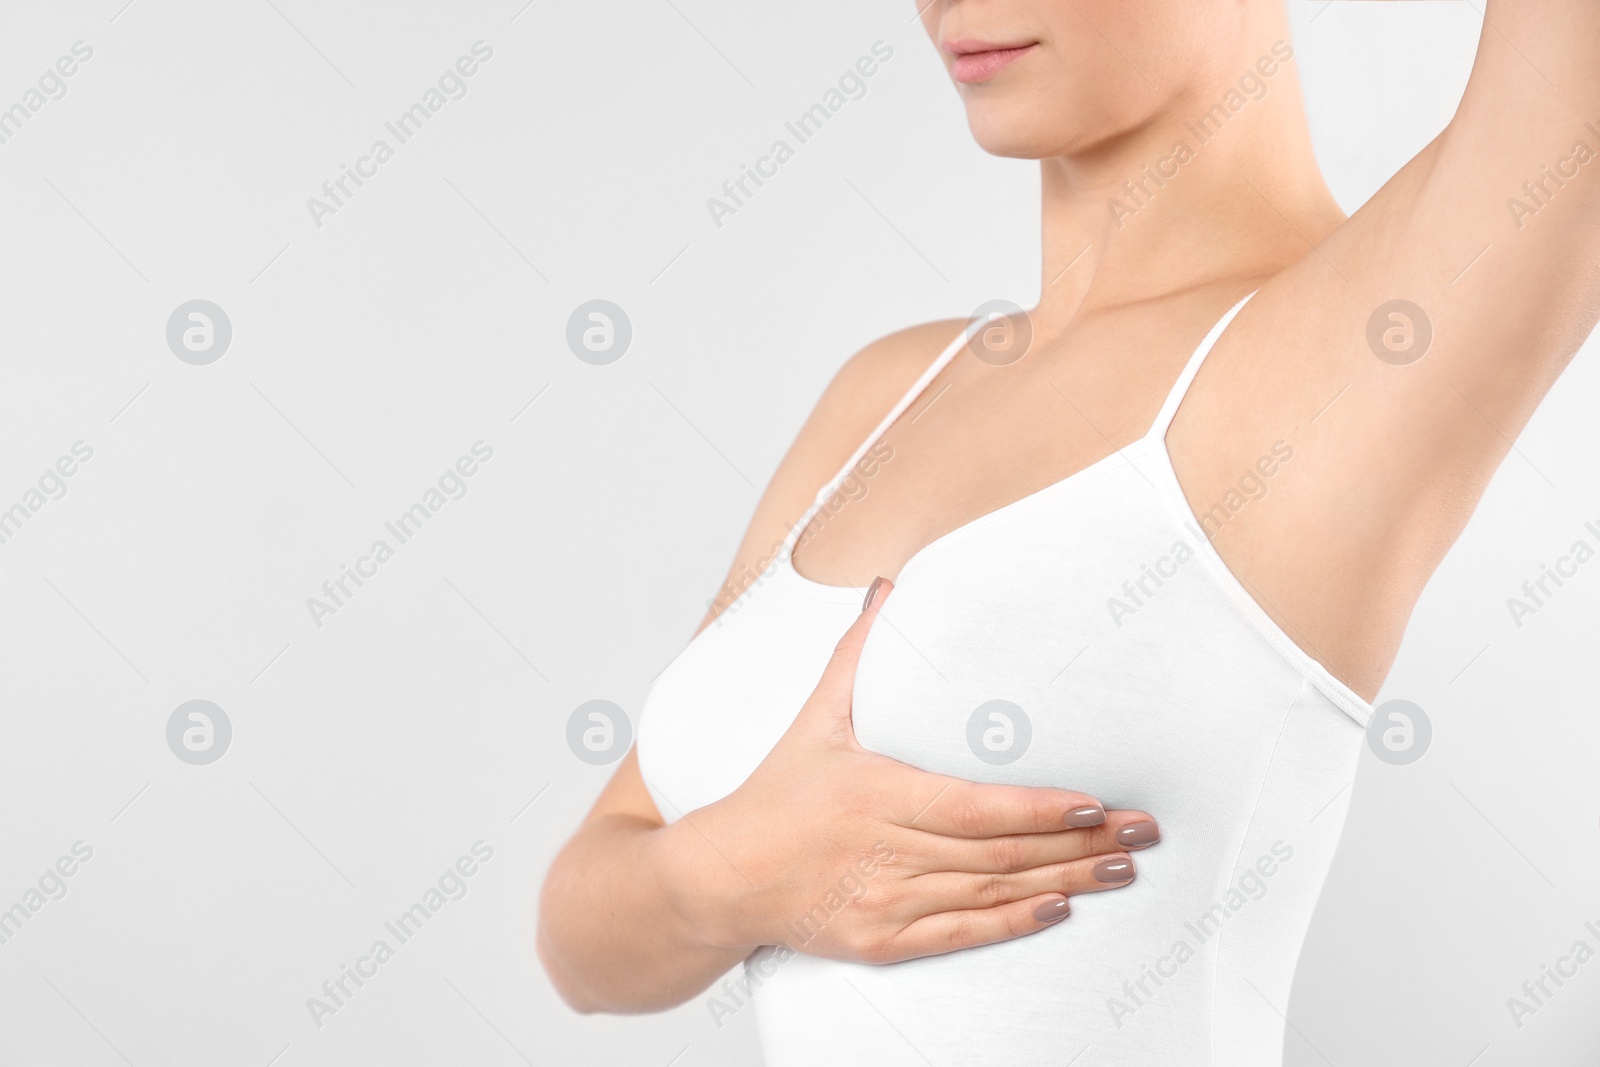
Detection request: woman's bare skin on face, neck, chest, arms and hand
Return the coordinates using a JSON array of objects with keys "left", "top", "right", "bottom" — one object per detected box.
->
[{"left": 539, "top": 0, "right": 1600, "bottom": 1011}]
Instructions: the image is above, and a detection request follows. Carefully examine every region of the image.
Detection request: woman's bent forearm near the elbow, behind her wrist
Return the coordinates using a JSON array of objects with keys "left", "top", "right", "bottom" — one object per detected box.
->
[{"left": 539, "top": 814, "right": 742, "bottom": 1014}]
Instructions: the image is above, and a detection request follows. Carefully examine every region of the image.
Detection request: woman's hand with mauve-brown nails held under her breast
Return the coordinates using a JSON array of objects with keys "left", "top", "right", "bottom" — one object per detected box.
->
[{"left": 669, "top": 579, "right": 1160, "bottom": 963}]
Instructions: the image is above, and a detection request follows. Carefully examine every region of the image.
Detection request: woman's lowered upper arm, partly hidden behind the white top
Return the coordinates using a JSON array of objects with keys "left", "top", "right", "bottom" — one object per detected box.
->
[{"left": 586, "top": 320, "right": 960, "bottom": 825}]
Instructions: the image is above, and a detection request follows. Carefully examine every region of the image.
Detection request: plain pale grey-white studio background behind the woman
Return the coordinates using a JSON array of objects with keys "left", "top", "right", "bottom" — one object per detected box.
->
[{"left": 0, "top": 0, "right": 1600, "bottom": 1067}]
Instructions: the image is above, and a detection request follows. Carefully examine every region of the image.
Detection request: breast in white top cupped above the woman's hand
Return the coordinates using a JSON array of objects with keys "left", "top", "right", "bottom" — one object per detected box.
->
[{"left": 854, "top": 469, "right": 1324, "bottom": 799}]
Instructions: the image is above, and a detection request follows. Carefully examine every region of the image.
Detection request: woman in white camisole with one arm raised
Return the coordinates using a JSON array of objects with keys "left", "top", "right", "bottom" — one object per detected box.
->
[{"left": 539, "top": 0, "right": 1600, "bottom": 1067}]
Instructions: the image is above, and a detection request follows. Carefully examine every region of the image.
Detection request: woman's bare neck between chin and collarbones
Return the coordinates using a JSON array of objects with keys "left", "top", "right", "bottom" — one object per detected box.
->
[{"left": 1034, "top": 32, "right": 1344, "bottom": 336}]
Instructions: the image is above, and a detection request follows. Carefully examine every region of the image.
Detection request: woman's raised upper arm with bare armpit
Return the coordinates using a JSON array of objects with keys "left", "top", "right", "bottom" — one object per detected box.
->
[{"left": 1168, "top": 0, "right": 1600, "bottom": 693}]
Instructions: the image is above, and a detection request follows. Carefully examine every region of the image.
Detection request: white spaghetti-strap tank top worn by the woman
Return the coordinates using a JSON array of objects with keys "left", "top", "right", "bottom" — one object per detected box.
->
[{"left": 638, "top": 296, "right": 1371, "bottom": 1067}]
